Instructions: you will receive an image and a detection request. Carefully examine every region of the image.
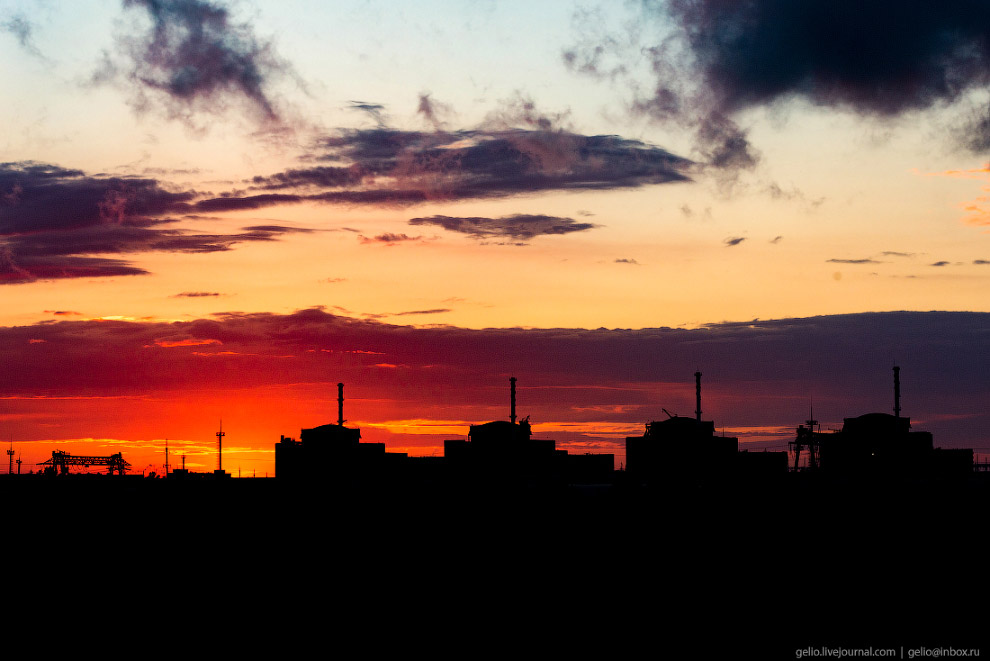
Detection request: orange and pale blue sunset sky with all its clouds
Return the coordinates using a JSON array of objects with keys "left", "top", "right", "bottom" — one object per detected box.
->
[{"left": 0, "top": 0, "right": 990, "bottom": 476}]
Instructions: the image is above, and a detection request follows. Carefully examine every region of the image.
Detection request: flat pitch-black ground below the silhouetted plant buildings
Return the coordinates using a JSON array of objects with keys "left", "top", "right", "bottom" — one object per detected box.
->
[{"left": 0, "top": 475, "right": 990, "bottom": 659}]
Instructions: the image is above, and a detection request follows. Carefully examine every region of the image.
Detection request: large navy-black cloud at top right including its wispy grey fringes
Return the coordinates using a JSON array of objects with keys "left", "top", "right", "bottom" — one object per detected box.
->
[{"left": 564, "top": 0, "right": 990, "bottom": 168}]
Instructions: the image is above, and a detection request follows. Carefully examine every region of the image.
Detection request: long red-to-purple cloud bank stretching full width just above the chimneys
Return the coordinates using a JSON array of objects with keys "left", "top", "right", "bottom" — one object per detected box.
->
[{"left": 0, "top": 309, "right": 990, "bottom": 447}]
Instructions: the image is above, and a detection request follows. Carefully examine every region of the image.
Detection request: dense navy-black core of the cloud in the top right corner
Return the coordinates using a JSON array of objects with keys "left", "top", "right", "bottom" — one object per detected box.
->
[{"left": 665, "top": 0, "right": 990, "bottom": 116}]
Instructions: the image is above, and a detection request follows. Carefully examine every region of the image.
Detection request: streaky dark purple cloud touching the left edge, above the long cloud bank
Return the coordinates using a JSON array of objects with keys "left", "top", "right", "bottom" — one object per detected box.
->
[{"left": 0, "top": 163, "right": 307, "bottom": 283}]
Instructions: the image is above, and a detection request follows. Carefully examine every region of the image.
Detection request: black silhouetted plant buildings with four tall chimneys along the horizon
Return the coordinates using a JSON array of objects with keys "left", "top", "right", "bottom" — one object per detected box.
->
[{"left": 7, "top": 367, "right": 982, "bottom": 489}]
